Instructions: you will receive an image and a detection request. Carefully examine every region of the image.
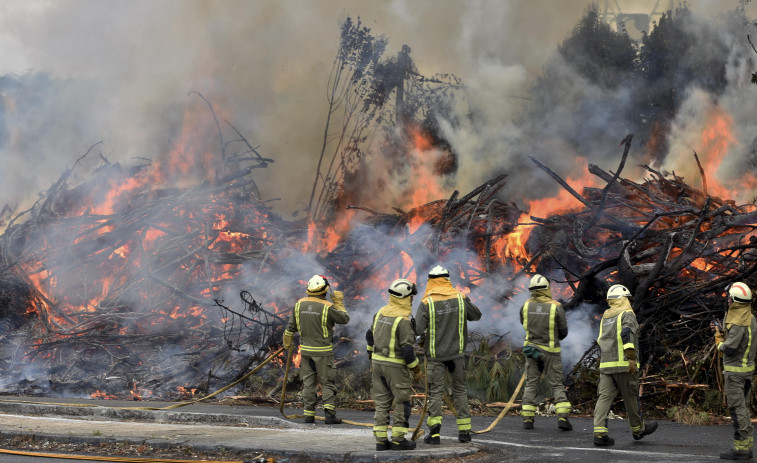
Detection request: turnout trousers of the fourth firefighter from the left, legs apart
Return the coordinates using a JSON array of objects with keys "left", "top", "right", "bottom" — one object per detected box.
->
[{"left": 521, "top": 351, "right": 571, "bottom": 421}]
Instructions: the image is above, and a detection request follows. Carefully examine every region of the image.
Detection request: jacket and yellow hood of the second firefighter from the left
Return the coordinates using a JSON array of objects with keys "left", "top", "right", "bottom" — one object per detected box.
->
[{"left": 365, "top": 295, "right": 418, "bottom": 368}]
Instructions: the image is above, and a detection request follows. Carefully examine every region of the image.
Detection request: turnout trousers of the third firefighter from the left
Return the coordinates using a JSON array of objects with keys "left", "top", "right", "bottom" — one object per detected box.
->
[{"left": 426, "top": 357, "right": 471, "bottom": 434}]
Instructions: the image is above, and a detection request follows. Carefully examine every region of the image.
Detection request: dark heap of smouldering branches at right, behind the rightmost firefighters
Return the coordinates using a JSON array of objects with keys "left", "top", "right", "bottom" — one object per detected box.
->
[{"left": 525, "top": 139, "right": 757, "bottom": 342}]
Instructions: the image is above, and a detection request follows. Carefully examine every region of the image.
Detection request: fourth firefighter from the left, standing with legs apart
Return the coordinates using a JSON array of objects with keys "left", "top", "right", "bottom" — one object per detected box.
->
[{"left": 520, "top": 274, "right": 573, "bottom": 431}]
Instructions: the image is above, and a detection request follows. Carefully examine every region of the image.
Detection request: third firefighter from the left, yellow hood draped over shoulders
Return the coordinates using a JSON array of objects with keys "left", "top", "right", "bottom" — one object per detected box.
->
[{"left": 415, "top": 265, "right": 481, "bottom": 445}]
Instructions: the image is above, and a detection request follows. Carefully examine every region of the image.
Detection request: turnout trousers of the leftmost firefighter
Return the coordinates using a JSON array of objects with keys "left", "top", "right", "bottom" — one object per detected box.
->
[{"left": 300, "top": 354, "right": 336, "bottom": 416}]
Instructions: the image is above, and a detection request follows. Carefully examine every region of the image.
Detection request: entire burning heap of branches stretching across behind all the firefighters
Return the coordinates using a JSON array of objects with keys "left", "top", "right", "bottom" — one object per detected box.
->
[{"left": 0, "top": 127, "right": 757, "bottom": 410}]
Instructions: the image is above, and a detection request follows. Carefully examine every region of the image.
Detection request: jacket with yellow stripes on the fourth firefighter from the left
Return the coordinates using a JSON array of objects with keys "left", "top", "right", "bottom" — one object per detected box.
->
[{"left": 520, "top": 288, "right": 568, "bottom": 354}]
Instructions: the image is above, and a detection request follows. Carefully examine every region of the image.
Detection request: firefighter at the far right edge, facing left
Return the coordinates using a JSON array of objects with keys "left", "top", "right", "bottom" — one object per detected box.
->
[{"left": 713, "top": 282, "right": 757, "bottom": 460}]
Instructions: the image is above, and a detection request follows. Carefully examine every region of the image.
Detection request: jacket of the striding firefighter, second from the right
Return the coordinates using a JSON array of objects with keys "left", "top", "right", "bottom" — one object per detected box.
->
[{"left": 597, "top": 297, "right": 641, "bottom": 374}]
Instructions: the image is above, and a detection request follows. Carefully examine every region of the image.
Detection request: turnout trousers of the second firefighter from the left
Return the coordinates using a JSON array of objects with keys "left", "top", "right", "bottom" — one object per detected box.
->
[{"left": 371, "top": 360, "right": 413, "bottom": 443}]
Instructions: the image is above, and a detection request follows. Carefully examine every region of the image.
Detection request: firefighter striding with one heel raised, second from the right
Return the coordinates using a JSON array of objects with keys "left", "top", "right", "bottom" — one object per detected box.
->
[{"left": 594, "top": 285, "right": 657, "bottom": 447}]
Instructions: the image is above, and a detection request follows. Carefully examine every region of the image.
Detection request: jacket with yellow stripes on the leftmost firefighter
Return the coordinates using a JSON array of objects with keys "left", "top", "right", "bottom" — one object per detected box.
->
[{"left": 284, "top": 294, "right": 350, "bottom": 357}]
